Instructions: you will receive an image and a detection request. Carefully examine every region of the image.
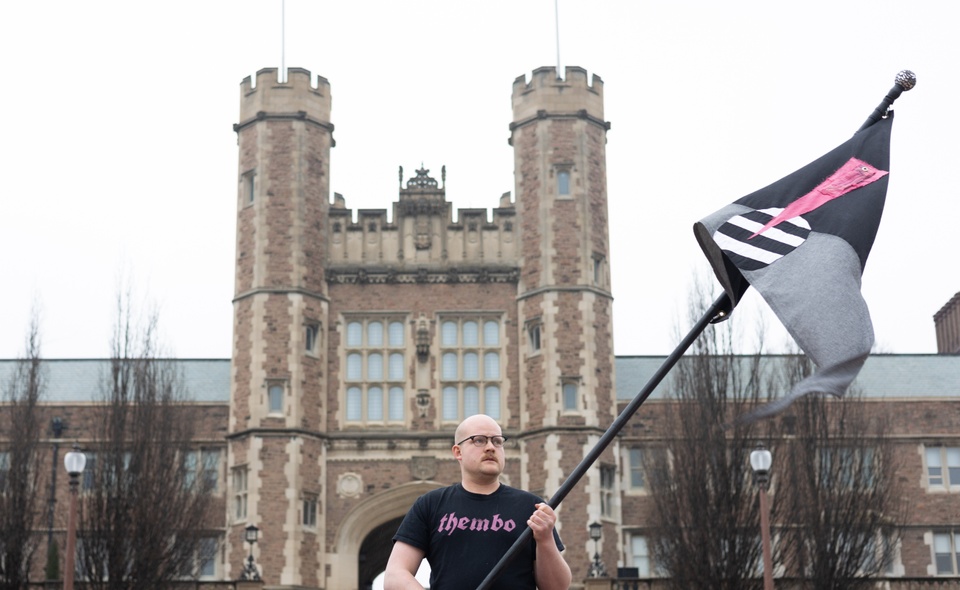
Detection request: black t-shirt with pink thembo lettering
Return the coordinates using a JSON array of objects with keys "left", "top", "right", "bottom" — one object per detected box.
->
[{"left": 393, "top": 484, "right": 563, "bottom": 590}]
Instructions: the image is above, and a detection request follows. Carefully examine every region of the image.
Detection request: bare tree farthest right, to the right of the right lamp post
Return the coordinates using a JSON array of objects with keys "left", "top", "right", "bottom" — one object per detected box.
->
[{"left": 775, "top": 357, "right": 907, "bottom": 590}]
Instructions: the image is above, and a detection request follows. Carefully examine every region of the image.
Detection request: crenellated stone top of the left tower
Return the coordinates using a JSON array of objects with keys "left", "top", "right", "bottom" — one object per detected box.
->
[{"left": 234, "top": 68, "right": 333, "bottom": 131}]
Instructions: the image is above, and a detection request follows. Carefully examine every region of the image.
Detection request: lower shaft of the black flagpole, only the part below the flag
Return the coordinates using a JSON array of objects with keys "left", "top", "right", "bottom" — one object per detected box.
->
[{"left": 477, "top": 293, "right": 733, "bottom": 590}]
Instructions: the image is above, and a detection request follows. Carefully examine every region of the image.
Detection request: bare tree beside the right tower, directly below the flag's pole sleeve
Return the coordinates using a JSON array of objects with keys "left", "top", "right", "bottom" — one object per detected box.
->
[{"left": 644, "top": 287, "right": 765, "bottom": 590}]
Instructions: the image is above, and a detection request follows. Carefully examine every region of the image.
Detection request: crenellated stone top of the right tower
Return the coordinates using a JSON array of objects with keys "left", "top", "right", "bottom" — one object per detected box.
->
[{"left": 510, "top": 66, "right": 609, "bottom": 129}]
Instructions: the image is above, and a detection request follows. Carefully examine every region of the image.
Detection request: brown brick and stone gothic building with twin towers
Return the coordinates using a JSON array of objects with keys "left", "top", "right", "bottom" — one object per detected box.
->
[{"left": 0, "top": 67, "right": 960, "bottom": 590}]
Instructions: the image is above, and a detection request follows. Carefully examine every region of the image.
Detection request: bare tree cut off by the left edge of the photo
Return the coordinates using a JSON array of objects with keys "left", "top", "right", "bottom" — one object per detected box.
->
[{"left": 0, "top": 308, "right": 44, "bottom": 590}]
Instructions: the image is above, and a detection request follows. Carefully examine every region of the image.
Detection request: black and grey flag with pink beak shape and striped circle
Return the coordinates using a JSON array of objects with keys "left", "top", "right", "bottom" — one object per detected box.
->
[{"left": 694, "top": 111, "right": 893, "bottom": 422}]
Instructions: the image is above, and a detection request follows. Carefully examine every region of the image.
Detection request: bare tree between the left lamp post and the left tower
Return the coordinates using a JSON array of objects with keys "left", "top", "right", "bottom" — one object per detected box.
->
[{"left": 78, "top": 298, "right": 215, "bottom": 590}]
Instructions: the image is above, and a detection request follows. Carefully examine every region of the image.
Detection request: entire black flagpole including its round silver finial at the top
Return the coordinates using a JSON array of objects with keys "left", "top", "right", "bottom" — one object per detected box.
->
[{"left": 477, "top": 70, "right": 917, "bottom": 590}]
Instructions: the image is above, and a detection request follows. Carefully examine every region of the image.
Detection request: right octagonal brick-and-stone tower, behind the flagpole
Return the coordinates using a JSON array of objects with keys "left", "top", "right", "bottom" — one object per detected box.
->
[{"left": 510, "top": 67, "right": 620, "bottom": 580}]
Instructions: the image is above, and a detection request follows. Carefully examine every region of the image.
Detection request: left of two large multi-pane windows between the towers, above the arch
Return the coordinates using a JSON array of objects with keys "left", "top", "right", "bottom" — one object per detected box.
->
[{"left": 344, "top": 318, "right": 407, "bottom": 424}]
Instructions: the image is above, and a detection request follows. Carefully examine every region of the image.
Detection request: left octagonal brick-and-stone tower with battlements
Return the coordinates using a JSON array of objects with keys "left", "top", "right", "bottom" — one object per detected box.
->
[{"left": 225, "top": 68, "right": 334, "bottom": 587}]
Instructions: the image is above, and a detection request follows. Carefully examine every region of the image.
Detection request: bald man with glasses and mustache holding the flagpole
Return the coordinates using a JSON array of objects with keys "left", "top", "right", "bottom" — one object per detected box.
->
[{"left": 383, "top": 414, "right": 571, "bottom": 590}]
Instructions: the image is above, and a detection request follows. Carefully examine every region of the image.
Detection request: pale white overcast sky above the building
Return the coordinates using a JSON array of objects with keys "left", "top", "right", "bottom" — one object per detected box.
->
[{"left": 0, "top": 0, "right": 960, "bottom": 358}]
